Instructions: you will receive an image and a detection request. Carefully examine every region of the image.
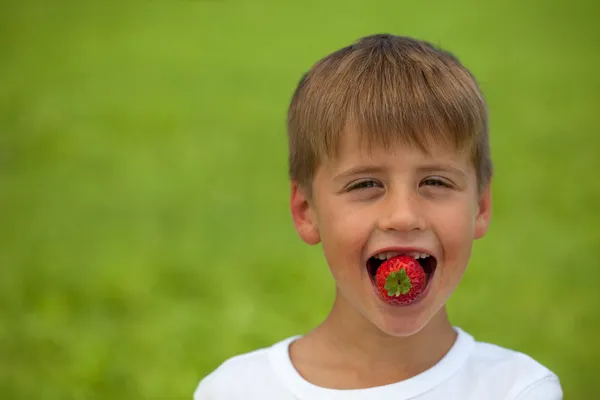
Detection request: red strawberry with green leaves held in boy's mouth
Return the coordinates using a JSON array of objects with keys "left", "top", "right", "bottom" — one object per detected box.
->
[{"left": 375, "top": 255, "right": 427, "bottom": 305}]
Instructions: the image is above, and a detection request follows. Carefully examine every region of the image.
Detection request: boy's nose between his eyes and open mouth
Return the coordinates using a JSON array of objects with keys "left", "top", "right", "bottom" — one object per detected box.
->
[{"left": 378, "top": 190, "right": 426, "bottom": 232}]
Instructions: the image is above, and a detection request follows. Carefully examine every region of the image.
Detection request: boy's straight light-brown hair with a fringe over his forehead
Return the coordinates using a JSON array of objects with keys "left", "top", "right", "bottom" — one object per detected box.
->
[{"left": 288, "top": 34, "right": 492, "bottom": 195}]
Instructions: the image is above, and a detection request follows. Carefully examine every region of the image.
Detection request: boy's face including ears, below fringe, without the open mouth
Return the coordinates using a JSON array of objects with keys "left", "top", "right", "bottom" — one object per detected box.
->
[{"left": 291, "top": 126, "right": 491, "bottom": 336}]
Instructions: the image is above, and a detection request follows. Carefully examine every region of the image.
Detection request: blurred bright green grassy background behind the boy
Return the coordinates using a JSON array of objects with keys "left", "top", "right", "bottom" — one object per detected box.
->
[{"left": 0, "top": 0, "right": 600, "bottom": 400}]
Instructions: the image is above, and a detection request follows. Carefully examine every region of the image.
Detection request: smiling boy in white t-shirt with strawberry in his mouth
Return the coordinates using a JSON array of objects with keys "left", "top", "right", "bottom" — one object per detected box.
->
[{"left": 194, "top": 35, "right": 562, "bottom": 400}]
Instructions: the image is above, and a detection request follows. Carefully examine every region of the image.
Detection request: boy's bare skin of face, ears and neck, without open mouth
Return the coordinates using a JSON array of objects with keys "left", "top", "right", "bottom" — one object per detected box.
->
[{"left": 290, "top": 129, "right": 491, "bottom": 389}]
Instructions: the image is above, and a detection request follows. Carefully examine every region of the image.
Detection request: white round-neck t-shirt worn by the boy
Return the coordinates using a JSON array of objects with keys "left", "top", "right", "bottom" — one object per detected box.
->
[{"left": 194, "top": 328, "right": 563, "bottom": 400}]
